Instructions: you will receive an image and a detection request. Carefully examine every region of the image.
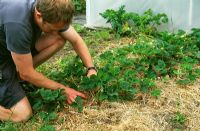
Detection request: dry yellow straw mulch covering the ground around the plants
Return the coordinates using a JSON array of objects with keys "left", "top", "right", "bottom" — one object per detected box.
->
[{"left": 47, "top": 38, "right": 200, "bottom": 131}]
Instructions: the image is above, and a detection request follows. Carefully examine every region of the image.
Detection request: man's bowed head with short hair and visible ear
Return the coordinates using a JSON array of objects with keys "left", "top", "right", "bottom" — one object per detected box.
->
[{"left": 35, "top": 0, "right": 74, "bottom": 32}]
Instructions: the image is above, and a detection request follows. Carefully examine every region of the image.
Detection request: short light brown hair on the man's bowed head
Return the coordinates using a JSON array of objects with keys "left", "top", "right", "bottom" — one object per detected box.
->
[{"left": 36, "top": 0, "right": 74, "bottom": 24}]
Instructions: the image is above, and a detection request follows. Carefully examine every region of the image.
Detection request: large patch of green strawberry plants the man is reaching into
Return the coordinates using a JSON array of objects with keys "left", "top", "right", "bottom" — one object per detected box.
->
[{"left": 36, "top": 25, "right": 200, "bottom": 108}]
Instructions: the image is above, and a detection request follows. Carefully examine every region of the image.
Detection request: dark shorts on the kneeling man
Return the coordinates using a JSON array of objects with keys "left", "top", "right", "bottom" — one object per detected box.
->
[{"left": 0, "top": 60, "right": 26, "bottom": 109}]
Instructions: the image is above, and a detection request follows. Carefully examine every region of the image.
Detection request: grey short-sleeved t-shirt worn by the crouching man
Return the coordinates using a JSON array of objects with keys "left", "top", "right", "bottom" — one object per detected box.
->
[{"left": 0, "top": 0, "right": 41, "bottom": 56}]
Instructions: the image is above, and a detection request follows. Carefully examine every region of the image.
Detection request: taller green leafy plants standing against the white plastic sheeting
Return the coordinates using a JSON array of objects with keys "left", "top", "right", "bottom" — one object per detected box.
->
[{"left": 100, "top": 5, "right": 168, "bottom": 36}]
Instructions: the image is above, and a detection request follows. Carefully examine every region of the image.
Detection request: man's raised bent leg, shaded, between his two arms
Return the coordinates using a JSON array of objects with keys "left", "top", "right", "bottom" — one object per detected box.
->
[{"left": 33, "top": 32, "right": 65, "bottom": 68}]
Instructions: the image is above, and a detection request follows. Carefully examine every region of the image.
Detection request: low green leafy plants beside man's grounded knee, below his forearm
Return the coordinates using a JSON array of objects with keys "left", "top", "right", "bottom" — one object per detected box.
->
[{"left": 20, "top": 84, "right": 66, "bottom": 131}]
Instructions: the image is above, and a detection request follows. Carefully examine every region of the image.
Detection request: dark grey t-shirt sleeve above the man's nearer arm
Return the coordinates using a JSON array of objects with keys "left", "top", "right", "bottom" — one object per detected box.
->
[{"left": 4, "top": 23, "right": 32, "bottom": 54}]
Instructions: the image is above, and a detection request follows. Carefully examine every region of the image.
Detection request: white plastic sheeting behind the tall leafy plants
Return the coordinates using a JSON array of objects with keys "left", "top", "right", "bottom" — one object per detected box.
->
[{"left": 86, "top": 0, "right": 200, "bottom": 31}]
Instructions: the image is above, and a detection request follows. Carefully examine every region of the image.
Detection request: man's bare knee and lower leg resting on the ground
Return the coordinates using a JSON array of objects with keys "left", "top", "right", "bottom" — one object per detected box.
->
[{"left": 0, "top": 97, "right": 32, "bottom": 122}]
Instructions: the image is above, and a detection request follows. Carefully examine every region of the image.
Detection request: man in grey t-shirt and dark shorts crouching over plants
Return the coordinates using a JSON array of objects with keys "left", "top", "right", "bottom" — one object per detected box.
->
[{"left": 0, "top": 0, "right": 96, "bottom": 122}]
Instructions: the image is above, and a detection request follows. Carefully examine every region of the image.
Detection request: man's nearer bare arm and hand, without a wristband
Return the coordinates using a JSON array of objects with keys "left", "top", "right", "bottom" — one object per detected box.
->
[{"left": 11, "top": 52, "right": 86, "bottom": 104}]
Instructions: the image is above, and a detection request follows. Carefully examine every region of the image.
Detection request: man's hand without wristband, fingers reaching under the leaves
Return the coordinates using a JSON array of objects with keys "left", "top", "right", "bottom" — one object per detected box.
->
[{"left": 65, "top": 87, "right": 87, "bottom": 104}]
